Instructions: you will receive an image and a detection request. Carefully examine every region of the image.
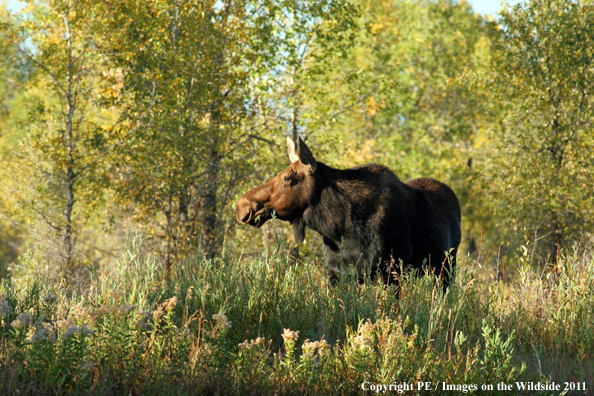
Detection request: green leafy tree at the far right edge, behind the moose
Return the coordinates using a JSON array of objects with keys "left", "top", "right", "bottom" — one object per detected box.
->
[{"left": 483, "top": 0, "right": 594, "bottom": 260}]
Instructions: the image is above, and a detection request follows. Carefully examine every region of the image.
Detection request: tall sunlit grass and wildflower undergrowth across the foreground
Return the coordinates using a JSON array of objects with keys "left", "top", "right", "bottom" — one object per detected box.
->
[{"left": 0, "top": 237, "right": 594, "bottom": 395}]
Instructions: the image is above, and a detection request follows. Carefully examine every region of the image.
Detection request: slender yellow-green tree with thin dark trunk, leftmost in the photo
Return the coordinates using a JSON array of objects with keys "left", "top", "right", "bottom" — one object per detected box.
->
[{"left": 3, "top": 0, "right": 118, "bottom": 273}]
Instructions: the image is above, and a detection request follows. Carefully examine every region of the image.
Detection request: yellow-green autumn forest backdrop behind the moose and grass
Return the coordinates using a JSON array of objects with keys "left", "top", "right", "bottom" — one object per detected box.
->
[{"left": 0, "top": 0, "right": 594, "bottom": 284}]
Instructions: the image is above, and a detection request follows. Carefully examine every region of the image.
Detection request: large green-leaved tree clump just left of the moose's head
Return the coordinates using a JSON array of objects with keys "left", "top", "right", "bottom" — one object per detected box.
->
[{"left": 97, "top": 0, "right": 358, "bottom": 268}]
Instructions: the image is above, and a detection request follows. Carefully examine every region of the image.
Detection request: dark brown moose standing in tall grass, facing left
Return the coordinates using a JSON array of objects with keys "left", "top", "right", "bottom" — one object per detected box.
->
[{"left": 236, "top": 136, "right": 462, "bottom": 290}]
